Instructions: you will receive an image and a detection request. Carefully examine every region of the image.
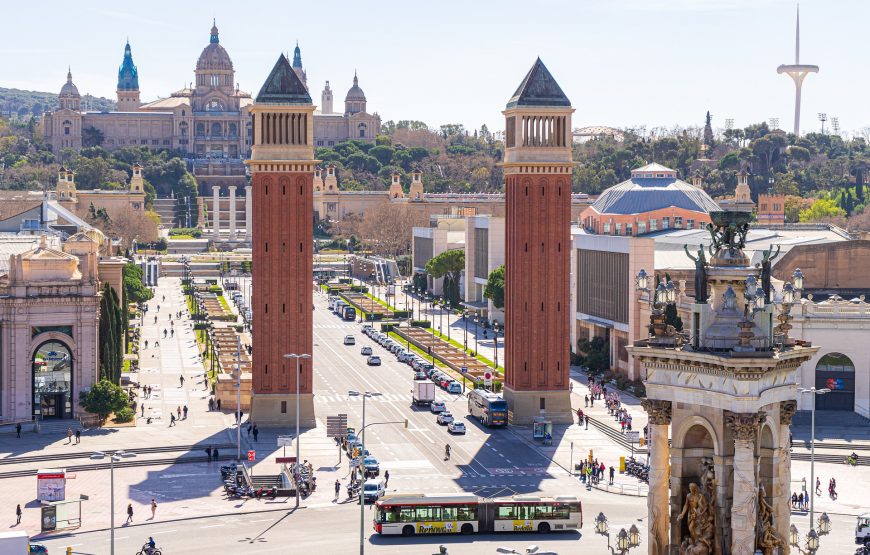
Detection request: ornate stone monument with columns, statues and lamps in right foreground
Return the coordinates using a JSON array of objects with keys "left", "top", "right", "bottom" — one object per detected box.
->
[{"left": 628, "top": 212, "right": 818, "bottom": 555}]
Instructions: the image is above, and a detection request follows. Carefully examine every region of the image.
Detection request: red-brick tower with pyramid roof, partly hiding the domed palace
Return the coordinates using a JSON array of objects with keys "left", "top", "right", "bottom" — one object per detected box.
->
[{"left": 247, "top": 55, "right": 317, "bottom": 426}]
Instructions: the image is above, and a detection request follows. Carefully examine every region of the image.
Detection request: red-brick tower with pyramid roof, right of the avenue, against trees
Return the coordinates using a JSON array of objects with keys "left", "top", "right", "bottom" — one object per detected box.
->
[{"left": 502, "top": 58, "right": 574, "bottom": 424}]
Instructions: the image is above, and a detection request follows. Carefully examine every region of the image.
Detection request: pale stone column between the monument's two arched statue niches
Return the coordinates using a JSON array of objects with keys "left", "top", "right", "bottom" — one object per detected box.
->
[{"left": 725, "top": 412, "right": 764, "bottom": 555}]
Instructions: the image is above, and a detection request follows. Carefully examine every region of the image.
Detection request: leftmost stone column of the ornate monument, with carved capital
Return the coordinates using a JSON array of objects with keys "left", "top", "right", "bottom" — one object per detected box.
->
[{"left": 641, "top": 399, "right": 671, "bottom": 553}]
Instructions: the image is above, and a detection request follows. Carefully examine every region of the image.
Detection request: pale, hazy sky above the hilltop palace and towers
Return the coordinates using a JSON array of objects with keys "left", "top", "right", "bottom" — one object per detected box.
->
[{"left": 0, "top": 0, "right": 870, "bottom": 135}]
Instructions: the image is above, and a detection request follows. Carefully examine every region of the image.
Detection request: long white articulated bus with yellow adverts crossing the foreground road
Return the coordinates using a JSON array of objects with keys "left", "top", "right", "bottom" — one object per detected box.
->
[{"left": 374, "top": 493, "right": 583, "bottom": 536}]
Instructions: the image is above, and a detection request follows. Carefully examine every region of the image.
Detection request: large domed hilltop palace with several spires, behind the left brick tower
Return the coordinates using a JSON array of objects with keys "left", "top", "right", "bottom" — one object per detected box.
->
[{"left": 41, "top": 25, "right": 381, "bottom": 195}]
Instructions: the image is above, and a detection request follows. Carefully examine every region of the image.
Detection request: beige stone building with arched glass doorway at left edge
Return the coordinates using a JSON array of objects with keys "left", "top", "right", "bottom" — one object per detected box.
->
[{"left": 0, "top": 236, "right": 100, "bottom": 422}]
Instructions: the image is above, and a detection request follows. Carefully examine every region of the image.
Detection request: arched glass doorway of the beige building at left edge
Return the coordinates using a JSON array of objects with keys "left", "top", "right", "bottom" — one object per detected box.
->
[{"left": 32, "top": 339, "right": 73, "bottom": 418}]
